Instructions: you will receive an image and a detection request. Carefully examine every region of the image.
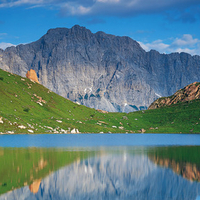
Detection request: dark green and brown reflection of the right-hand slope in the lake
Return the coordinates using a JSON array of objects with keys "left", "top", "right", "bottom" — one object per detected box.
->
[{"left": 148, "top": 146, "right": 200, "bottom": 182}]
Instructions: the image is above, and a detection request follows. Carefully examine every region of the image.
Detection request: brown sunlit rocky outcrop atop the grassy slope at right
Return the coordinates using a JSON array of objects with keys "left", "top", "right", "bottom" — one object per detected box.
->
[{"left": 148, "top": 82, "right": 200, "bottom": 109}]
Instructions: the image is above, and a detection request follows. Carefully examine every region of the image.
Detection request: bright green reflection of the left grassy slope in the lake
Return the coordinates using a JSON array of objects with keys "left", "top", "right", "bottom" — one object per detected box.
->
[{"left": 0, "top": 148, "right": 94, "bottom": 195}]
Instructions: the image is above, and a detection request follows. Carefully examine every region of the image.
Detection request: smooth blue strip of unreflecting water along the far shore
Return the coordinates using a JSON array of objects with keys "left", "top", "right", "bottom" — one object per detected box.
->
[{"left": 0, "top": 134, "right": 200, "bottom": 147}]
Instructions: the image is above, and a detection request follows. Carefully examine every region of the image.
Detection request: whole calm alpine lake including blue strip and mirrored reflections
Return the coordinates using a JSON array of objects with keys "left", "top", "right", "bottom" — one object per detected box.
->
[{"left": 0, "top": 134, "right": 200, "bottom": 200}]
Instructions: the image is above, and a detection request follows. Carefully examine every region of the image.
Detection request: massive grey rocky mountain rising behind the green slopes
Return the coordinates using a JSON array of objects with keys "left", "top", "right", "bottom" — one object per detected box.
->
[{"left": 0, "top": 25, "right": 200, "bottom": 112}]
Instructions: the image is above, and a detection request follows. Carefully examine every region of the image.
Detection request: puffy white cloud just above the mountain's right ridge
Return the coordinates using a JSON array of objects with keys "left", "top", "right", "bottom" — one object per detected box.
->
[{"left": 139, "top": 34, "right": 200, "bottom": 55}]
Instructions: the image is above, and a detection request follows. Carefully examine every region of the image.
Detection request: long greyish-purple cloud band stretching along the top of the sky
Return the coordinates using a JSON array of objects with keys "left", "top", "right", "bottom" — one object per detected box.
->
[{"left": 0, "top": 0, "right": 200, "bottom": 18}]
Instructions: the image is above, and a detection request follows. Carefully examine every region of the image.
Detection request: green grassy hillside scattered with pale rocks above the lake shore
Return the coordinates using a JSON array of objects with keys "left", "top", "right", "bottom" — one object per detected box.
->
[{"left": 0, "top": 70, "right": 200, "bottom": 134}]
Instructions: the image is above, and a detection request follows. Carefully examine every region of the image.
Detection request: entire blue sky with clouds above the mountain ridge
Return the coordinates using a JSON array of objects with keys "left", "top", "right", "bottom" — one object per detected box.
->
[{"left": 0, "top": 0, "right": 200, "bottom": 55}]
